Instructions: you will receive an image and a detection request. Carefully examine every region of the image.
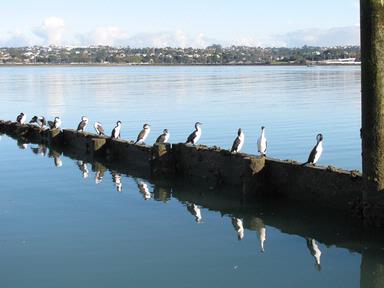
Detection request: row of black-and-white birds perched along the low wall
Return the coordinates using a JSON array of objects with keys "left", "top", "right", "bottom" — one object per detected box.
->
[{"left": 16, "top": 113, "right": 323, "bottom": 165}]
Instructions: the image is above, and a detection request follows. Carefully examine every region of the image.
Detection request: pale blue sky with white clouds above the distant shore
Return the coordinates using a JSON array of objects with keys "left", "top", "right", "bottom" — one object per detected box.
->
[{"left": 0, "top": 0, "right": 359, "bottom": 47}]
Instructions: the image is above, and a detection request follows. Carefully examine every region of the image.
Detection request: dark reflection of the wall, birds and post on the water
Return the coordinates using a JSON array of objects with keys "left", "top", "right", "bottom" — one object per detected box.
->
[{"left": 4, "top": 133, "right": 384, "bottom": 288}]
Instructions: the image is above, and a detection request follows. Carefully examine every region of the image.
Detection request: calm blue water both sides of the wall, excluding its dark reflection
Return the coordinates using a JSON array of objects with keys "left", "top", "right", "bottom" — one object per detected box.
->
[{"left": 0, "top": 67, "right": 376, "bottom": 288}]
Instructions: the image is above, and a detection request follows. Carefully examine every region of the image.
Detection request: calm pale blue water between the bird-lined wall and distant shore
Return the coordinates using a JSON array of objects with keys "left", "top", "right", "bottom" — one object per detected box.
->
[{"left": 0, "top": 66, "right": 361, "bottom": 169}]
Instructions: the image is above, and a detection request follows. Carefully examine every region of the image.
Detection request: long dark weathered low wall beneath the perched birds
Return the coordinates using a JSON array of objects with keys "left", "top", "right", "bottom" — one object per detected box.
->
[{"left": 0, "top": 121, "right": 363, "bottom": 211}]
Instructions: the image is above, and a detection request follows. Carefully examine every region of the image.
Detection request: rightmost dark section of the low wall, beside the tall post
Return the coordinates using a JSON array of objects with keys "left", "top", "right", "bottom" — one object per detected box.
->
[{"left": 264, "top": 158, "right": 363, "bottom": 209}]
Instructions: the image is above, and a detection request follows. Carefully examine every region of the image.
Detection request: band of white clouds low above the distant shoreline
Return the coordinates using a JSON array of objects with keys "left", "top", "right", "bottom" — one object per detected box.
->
[{"left": 0, "top": 17, "right": 360, "bottom": 48}]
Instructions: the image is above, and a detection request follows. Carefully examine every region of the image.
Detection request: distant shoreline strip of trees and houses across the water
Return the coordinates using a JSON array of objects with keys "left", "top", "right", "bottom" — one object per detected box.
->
[{"left": 0, "top": 45, "right": 360, "bottom": 65}]
